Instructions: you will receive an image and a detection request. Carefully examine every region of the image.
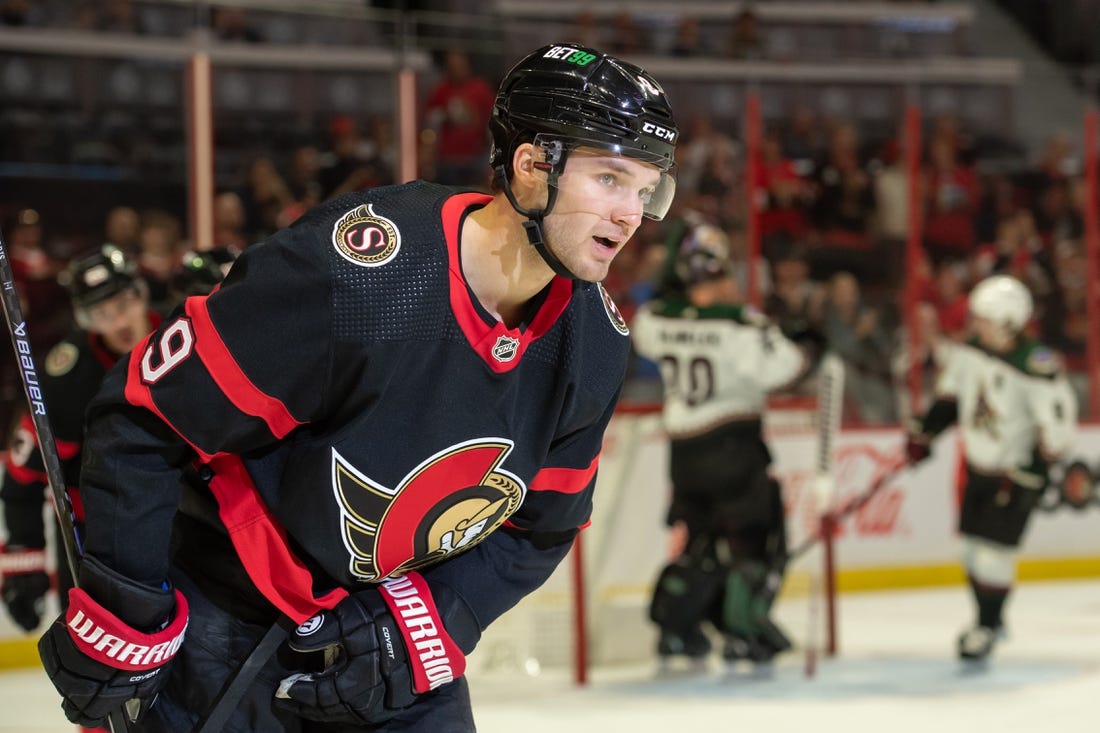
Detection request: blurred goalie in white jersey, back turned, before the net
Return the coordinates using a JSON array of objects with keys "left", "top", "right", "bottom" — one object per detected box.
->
[{"left": 631, "top": 225, "right": 809, "bottom": 671}]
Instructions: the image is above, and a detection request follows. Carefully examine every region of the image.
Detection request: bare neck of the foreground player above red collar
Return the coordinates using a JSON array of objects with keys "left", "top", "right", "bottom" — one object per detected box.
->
[{"left": 459, "top": 196, "right": 553, "bottom": 328}]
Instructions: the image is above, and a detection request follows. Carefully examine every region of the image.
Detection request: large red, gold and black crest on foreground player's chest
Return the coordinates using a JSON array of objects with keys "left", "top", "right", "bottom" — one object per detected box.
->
[{"left": 332, "top": 438, "right": 527, "bottom": 581}]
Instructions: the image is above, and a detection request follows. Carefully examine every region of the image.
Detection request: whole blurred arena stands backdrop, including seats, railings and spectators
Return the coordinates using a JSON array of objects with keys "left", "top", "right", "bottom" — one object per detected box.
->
[{"left": 0, "top": 0, "right": 1100, "bottom": 433}]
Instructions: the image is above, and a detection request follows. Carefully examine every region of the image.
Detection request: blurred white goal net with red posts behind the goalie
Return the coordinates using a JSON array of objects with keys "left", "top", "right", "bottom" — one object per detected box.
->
[{"left": 470, "top": 396, "right": 834, "bottom": 683}]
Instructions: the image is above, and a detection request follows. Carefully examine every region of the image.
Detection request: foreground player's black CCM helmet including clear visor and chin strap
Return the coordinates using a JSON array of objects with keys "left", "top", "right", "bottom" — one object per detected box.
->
[{"left": 490, "top": 43, "right": 680, "bottom": 277}]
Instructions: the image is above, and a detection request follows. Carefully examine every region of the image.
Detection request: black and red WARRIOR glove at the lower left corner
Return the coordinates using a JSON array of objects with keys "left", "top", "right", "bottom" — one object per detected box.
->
[{"left": 39, "top": 556, "right": 187, "bottom": 727}]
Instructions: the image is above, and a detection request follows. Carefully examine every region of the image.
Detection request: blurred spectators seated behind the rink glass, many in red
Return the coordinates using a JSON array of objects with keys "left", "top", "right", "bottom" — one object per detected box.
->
[{"left": 0, "top": 0, "right": 1098, "bottom": 431}]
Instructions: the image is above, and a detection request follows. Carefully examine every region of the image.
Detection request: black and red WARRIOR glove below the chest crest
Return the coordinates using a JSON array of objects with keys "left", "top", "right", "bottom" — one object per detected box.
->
[{"left": 275, "top": 572, "right": 466, "bottom": 725}]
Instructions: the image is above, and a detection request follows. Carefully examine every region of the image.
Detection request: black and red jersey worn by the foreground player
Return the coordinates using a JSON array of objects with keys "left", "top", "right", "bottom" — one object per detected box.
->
[{"left": 83, "top": 182, "right": 628, "bottom": 627}]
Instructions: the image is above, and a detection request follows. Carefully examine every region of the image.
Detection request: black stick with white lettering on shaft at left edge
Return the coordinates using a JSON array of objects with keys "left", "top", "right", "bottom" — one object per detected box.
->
[{"left": 0, "top": 230, "right": 132, "bottom": 733}]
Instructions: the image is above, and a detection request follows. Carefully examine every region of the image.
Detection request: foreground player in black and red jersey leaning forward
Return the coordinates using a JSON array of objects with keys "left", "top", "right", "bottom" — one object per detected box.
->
[{"left": 40, "top": 44, "right": 678, "bottom": 733}]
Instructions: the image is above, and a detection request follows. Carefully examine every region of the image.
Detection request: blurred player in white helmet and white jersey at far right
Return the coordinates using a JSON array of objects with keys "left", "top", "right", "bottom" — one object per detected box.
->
[{"left": 908, "top": 275, "right": 1077, "bottom": 660}]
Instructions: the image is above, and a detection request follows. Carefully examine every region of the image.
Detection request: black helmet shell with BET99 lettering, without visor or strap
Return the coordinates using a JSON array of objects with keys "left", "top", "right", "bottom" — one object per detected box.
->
[{"left": 490, "top": 44, "right": 680, "bottom": 179}]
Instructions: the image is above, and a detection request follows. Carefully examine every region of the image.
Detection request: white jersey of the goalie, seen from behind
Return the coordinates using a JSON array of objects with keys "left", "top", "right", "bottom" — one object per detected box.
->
[{"left": 630, "top": 298, "right": 804, "bottom": 437}]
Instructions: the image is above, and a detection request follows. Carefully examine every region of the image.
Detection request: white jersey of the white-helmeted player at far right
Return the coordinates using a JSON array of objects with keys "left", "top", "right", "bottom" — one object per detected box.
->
[{"left": 936, "top": 341, "right": 1077, "bottom": 472}]
